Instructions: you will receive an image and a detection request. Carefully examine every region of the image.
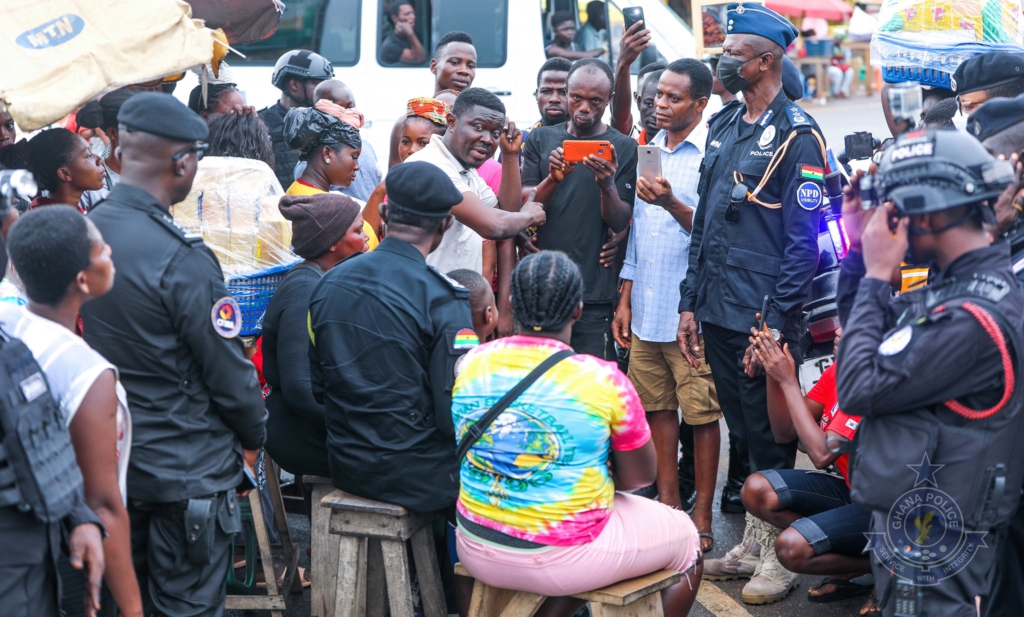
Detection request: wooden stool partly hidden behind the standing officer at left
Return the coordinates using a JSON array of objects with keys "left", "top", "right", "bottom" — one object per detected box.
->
[{"left": 224, "top": 453, "right": 302, "bottom": 617}]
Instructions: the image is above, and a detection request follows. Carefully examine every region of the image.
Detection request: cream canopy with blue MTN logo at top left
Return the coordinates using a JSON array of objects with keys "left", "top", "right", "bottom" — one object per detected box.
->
[{"left": 0, "top": 0, "right": 226, "bottom": 131}]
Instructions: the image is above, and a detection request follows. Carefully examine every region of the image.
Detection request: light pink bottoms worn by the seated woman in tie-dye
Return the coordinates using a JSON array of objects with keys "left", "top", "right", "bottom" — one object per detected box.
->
[{"left": 457, "top": 493, "right": 700, "bottom": 597}]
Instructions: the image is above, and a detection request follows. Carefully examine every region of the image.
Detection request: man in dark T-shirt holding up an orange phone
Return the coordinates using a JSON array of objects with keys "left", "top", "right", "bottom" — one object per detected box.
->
[{"left": 522, "top": 59, "right": 637, "bottom": 360}]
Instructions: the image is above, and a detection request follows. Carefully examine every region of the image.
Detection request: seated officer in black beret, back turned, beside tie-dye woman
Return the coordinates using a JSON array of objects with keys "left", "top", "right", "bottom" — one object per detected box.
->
[{"left": 309, "top": 163, "right": 478, "bottom": 513}]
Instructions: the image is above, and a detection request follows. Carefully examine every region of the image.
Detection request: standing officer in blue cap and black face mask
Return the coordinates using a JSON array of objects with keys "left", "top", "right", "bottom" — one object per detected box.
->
[{"left": 678, "top": 2, "right": 824, "bottom": 482}]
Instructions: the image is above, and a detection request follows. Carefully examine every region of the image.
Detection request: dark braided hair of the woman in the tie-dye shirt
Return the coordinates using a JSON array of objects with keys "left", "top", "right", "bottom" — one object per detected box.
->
[{"left": 512, "top": 251, "right": 583, "bottom": 332}]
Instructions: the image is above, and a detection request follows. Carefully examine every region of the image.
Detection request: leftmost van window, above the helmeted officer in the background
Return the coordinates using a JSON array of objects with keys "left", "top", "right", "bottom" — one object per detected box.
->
[{"left": 230, "top": 0, "right": 361, "bottom": 67}]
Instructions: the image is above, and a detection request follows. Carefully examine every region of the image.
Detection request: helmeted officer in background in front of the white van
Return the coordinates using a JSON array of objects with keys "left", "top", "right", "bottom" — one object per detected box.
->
[{"left": 257, "top": 49, "right": 334, "bottom": 189}]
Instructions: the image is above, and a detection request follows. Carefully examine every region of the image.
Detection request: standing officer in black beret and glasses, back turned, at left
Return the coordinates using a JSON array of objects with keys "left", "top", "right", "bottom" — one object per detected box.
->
[{"left": 82, "top": 93, "right": 266, "bottom": 616}]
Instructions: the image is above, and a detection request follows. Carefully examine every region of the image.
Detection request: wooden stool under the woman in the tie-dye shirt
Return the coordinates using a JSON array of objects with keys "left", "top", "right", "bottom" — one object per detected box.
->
[{"left": 455, "top": 564, "right": 683, "bottom": 617}]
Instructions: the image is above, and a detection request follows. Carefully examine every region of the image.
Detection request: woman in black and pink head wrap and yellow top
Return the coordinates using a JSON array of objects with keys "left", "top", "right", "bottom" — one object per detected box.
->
[{"left": 284, "top": 105, "right": 379, "bottom": 251}]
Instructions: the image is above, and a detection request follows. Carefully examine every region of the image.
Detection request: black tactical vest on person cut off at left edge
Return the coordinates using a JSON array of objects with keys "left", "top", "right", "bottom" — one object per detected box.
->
[{"left": 0, "top": 330, "right": 82, "bottom": 523}]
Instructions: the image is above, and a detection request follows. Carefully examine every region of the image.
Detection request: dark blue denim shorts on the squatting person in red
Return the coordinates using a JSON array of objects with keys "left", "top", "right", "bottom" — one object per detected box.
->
[{"left": 760, "top": 470, "right": 871, "bottom": 556}]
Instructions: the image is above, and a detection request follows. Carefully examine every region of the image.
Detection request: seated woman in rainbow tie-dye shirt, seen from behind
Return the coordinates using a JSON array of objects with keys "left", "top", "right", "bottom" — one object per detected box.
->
[{"left": 452, "top": 251, "right": 702, "bottom": 617}]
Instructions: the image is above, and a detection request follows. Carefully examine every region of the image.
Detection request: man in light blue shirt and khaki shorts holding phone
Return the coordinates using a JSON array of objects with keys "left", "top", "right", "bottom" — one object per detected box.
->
[{"left": 612, "top": 58, "right": 722, "bottom": 552}]
